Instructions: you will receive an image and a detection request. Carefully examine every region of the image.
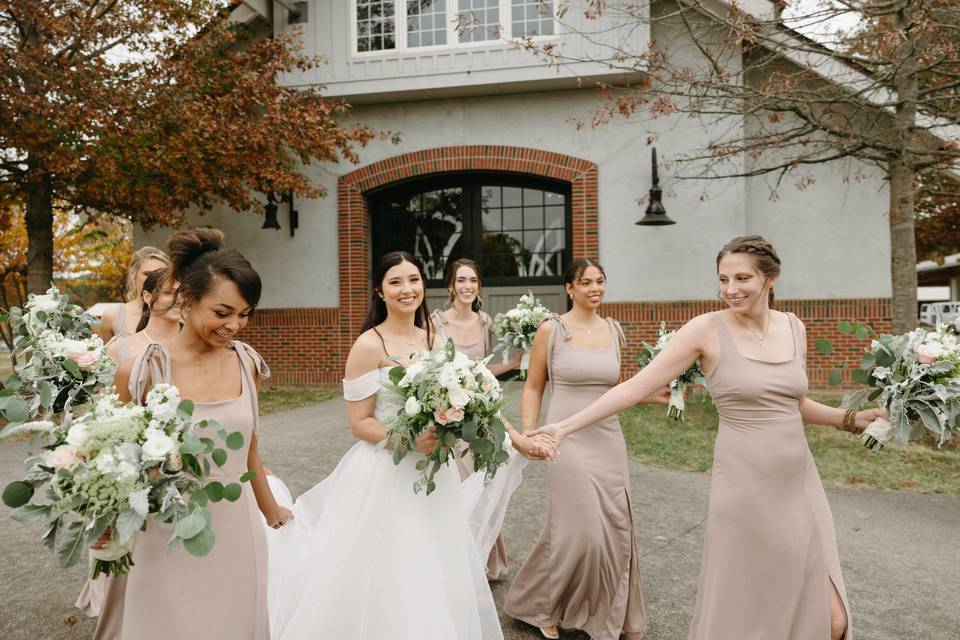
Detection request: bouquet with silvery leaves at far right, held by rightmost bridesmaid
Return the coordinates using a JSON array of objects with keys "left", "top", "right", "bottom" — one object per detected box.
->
[{"left": 842, "top": 324, "right": 960, "bottom": 451}]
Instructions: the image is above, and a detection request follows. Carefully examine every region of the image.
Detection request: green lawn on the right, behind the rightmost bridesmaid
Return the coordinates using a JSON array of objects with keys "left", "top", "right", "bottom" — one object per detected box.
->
[{"left": 620, "top": 394, "right": 960, "bottom": 495}]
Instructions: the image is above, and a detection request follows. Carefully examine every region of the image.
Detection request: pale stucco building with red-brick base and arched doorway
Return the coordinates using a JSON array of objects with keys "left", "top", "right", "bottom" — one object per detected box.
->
[{"left": 137, "top": 0, "right": 891, "bottom": 384}]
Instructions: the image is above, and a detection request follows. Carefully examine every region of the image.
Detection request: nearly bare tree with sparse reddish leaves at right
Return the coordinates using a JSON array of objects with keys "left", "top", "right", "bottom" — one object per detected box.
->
[{"left": 521, "top": 0, "right": 960, "bottom": 332}]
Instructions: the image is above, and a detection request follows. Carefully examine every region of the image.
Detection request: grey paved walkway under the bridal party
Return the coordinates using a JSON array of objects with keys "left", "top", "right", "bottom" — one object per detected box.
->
[{"left": 0, "top": 390, "right": 960, "bottom": 640}]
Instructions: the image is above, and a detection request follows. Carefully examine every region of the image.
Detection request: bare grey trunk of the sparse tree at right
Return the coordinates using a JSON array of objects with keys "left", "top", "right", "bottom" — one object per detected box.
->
[{"left": 889, "top": 159, "right": 917, "bottom": 333}]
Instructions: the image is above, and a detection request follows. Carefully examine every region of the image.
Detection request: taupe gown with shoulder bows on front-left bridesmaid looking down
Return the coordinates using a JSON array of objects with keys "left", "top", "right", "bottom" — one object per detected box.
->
[{"left": 120, "top": 341, "right": 270, "bottom": 640}]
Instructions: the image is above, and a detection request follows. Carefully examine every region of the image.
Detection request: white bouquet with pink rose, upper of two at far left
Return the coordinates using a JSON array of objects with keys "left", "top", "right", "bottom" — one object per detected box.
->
[{"left": 0, "top": 287, "right": 116, "bottom": 423}]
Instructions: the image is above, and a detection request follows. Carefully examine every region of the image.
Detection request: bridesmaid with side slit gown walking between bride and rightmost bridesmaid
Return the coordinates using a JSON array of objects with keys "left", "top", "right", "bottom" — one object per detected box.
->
[{"left": 503, "top": 258, "right": 656, "bottom": 640}]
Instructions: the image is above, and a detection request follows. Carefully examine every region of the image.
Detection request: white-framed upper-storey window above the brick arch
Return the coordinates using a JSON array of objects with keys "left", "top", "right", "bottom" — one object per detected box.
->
[{"left": 353, "top": 0, "right": 555, "bottom": 54}]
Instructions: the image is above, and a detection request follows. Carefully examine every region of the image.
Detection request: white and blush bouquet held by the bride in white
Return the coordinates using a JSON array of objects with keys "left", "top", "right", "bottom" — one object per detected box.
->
[{"left": 384, "top": 340, "right": 510, "bottom": 495}]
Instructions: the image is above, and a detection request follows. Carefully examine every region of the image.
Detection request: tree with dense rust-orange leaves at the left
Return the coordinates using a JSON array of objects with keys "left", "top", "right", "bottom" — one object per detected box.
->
[{"left": 0, "top": 0, "right": 374, "bottom": 291}]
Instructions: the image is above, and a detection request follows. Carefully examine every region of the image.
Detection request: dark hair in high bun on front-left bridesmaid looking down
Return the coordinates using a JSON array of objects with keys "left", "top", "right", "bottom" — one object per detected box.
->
[{"left": 167, "top": 229, "right": 263, "bottom": 308}]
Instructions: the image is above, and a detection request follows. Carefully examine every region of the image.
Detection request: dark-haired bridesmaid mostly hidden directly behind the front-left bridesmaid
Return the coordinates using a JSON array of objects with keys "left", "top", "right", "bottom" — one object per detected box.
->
[{"left": 76, "top": 268, "right": 180, "bottom": 640}]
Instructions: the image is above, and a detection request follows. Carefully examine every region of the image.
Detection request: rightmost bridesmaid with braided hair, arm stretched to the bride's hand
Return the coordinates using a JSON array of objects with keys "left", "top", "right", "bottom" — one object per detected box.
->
[{"left": 538, "top": 236, "right": 883, "bottom": 640}]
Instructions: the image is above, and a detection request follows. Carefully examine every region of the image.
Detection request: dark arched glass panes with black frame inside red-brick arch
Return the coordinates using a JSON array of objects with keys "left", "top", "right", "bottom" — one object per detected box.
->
[{"left": 369, "top": 173, "right": 571, "bottom": 286}]
